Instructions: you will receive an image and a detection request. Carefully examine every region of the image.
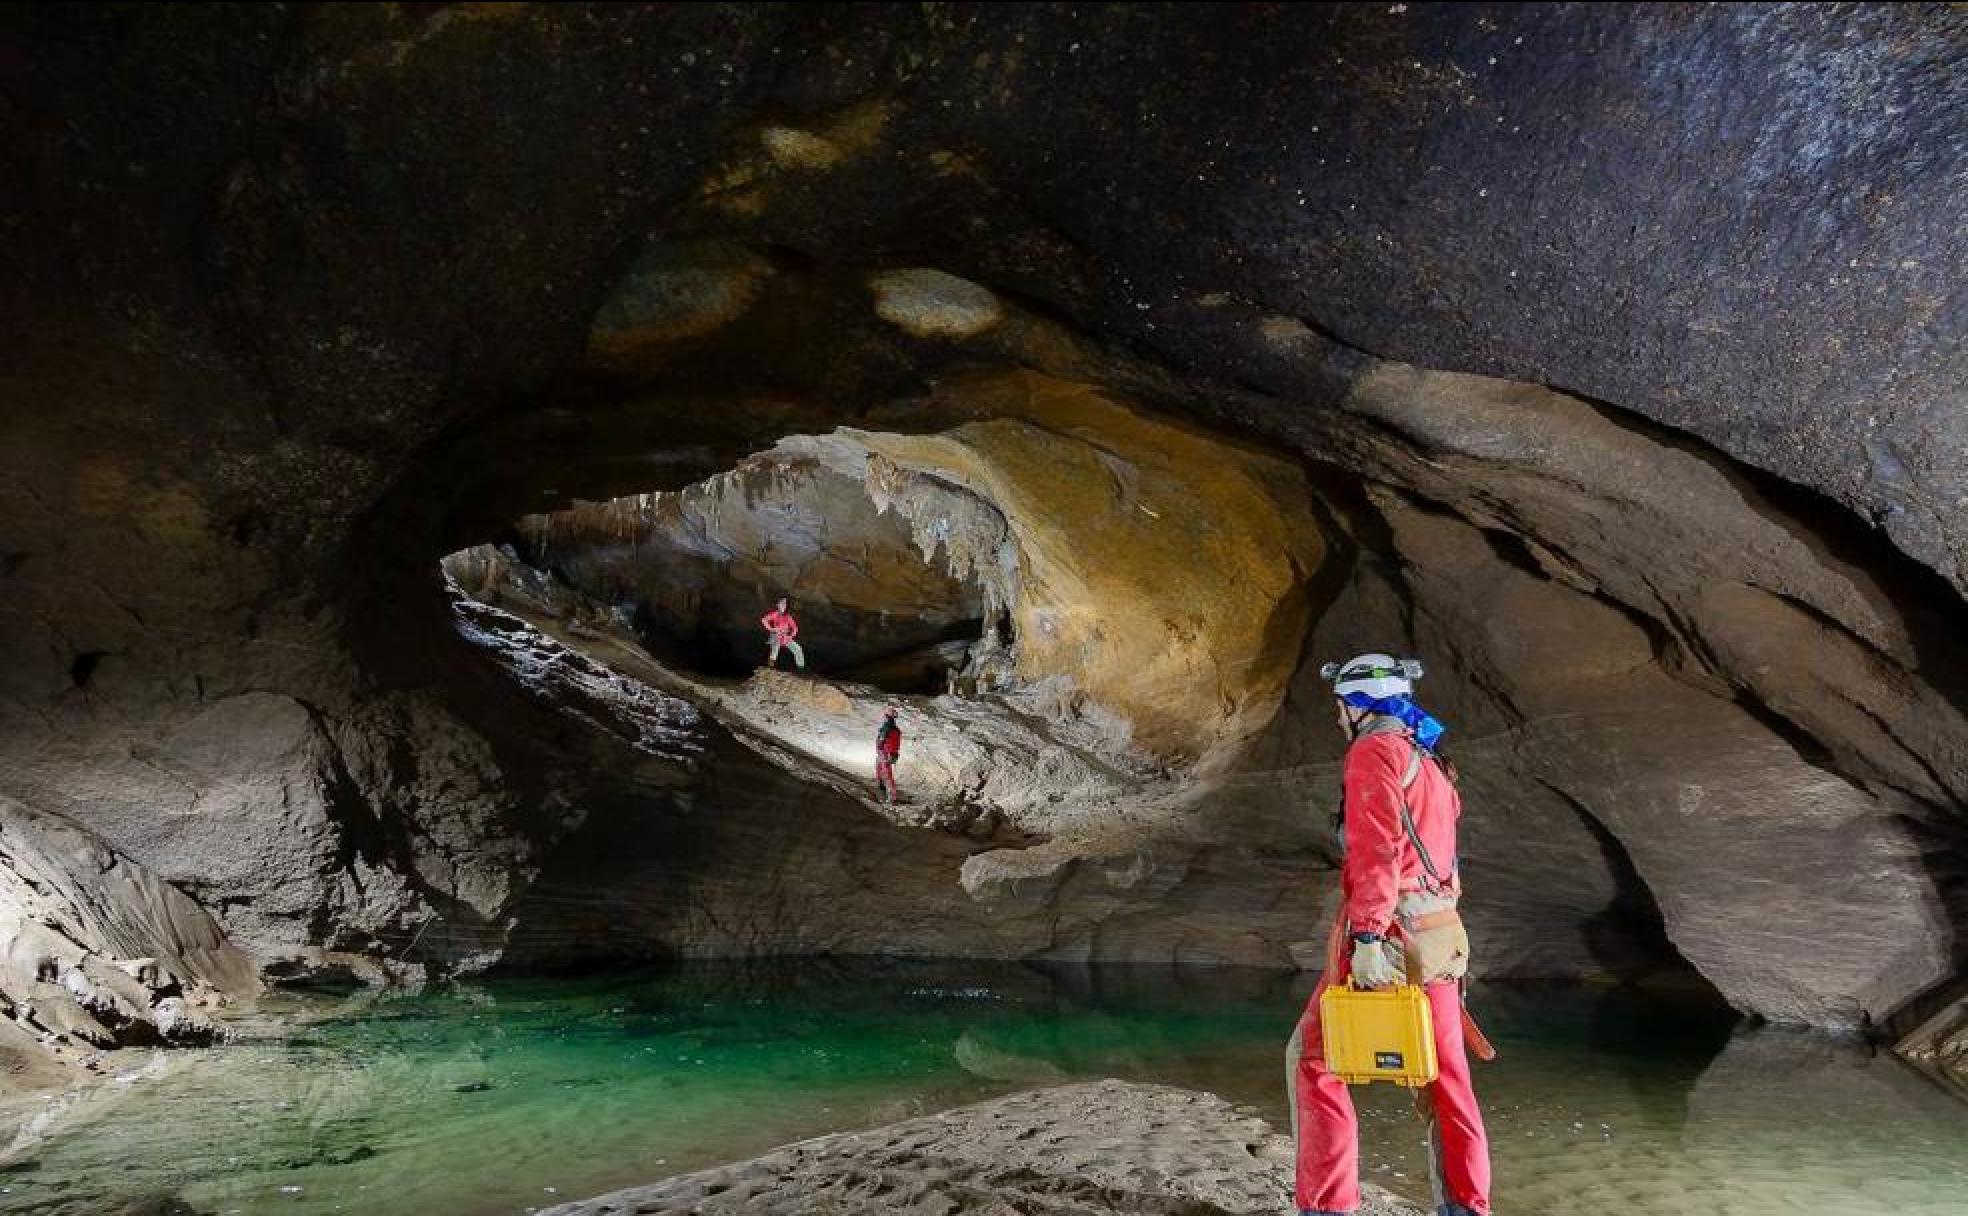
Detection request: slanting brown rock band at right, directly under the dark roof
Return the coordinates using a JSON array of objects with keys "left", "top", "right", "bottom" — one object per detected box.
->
[{"left": 1322, "top": 364, "right": 1968, "bottom": 805}]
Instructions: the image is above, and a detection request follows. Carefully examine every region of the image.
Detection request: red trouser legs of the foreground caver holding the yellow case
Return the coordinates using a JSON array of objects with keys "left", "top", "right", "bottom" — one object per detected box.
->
[{"left": 1285, "top": 968, "right": 1490, "bottom": 1216}]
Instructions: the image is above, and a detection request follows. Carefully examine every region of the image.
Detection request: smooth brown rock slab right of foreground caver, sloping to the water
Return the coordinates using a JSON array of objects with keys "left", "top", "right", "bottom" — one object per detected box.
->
[{"left": 1387, "top": 499, "right": 1952, "bottom": 1027}]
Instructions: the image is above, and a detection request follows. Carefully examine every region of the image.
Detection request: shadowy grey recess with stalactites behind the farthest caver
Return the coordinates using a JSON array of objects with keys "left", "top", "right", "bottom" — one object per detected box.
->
[{"left": 445, "top": 450, "right": 1012, "bottom": 695}]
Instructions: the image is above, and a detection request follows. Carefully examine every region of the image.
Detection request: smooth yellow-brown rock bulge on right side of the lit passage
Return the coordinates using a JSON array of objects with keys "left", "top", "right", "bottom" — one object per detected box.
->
[{"left": 854, "top": 372, "right": 1324, "bottom": 763}]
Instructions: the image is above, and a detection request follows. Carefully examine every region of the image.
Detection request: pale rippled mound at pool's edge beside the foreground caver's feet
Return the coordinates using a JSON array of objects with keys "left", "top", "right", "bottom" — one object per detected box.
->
[{"left": 547, "top": 1080, "right": 1419, "bottom": 1216}]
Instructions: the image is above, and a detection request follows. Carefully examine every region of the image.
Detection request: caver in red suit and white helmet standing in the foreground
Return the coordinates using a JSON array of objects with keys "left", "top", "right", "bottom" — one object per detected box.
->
[{"left": 1285, "top": 653, "right": 1494, "bottom": 1216}]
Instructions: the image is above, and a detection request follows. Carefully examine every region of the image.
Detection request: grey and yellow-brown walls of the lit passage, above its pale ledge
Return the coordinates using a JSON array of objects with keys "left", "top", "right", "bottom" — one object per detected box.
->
[{"left": 488, "top": 374, "right": 1324, "bottom": 765}]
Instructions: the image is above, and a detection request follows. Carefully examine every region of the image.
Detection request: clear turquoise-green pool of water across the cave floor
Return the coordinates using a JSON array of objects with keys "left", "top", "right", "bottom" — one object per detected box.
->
[{"left": 0, "top": 962, "right": 1968, "bottom": 1216}]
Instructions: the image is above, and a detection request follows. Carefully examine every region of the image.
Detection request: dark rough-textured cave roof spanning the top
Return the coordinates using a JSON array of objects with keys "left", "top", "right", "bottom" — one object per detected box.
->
[{"left": 0, "top": 4, "right": 1968, "bottom": 590}]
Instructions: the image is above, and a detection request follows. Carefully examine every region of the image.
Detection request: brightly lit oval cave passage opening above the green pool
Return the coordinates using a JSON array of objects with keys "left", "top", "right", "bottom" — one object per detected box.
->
[{"left": 441, "top": 385, "right": 1326, "bottom": 834}]
